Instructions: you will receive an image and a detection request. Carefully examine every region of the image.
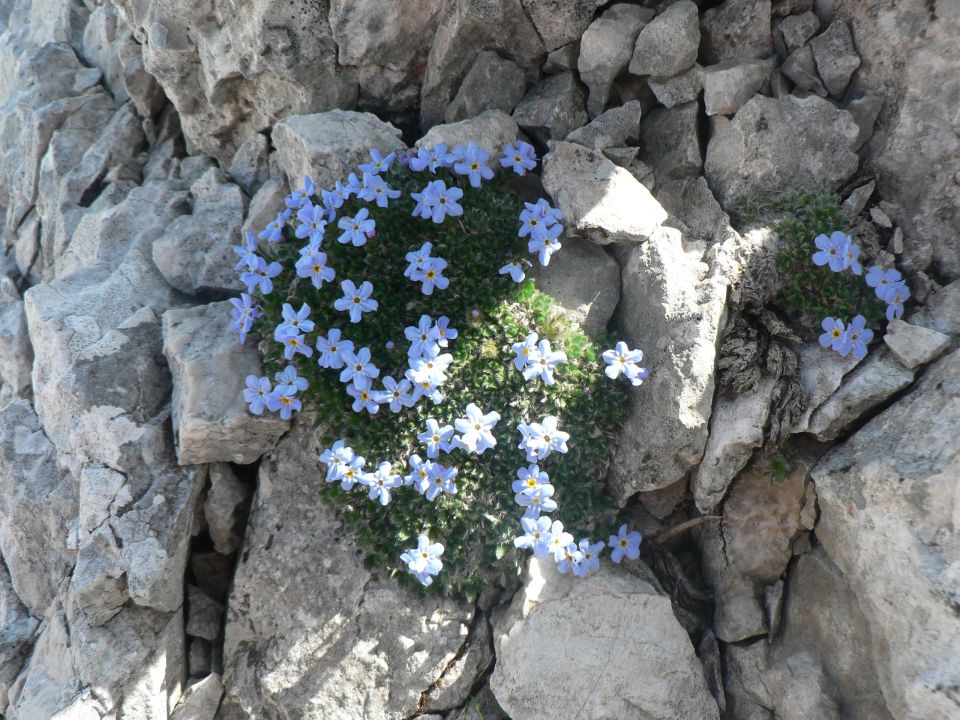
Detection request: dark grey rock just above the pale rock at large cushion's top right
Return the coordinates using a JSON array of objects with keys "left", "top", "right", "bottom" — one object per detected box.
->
[{"left": 444, "top": 50, "right": 526, "bottom": 123}]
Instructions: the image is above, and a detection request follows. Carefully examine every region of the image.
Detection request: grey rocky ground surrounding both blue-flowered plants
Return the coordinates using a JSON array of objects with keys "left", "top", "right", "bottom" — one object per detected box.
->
[{"left": 0, "top": 0, "right": 960, "bottom": 720}]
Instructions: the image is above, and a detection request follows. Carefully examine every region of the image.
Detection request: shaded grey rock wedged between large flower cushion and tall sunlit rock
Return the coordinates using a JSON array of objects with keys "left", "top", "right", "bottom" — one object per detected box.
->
[{"left": 529, "top": 237, "right": 620, "bottom": 337}]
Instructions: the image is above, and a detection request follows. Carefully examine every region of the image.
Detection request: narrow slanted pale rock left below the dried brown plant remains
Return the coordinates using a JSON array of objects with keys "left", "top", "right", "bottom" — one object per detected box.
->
[{"left": 690, "top": 378, "right": 776, "bottom": 515}]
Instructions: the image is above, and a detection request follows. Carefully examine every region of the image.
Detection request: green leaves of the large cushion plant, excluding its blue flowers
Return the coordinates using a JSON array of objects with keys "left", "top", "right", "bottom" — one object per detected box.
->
[{"left": 248, "top": 165, "right": 628, "bottom": 599}]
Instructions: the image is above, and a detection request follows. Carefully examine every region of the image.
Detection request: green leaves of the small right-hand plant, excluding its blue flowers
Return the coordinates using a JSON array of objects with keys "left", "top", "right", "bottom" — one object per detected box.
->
[{"left": 735, "top": 190, "right": 885, "bottom": 337}]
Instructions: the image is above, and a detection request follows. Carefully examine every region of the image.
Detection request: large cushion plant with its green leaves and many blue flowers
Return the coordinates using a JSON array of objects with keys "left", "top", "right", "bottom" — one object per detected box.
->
[{"left": 231, "top": 142, "right": 647, "bottom": 598}]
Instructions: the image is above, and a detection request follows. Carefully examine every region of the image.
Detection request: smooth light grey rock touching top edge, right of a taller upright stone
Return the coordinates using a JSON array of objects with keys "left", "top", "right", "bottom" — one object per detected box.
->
[{"left": 630, "top": 0, "right": 700, "bottom": 78}]
